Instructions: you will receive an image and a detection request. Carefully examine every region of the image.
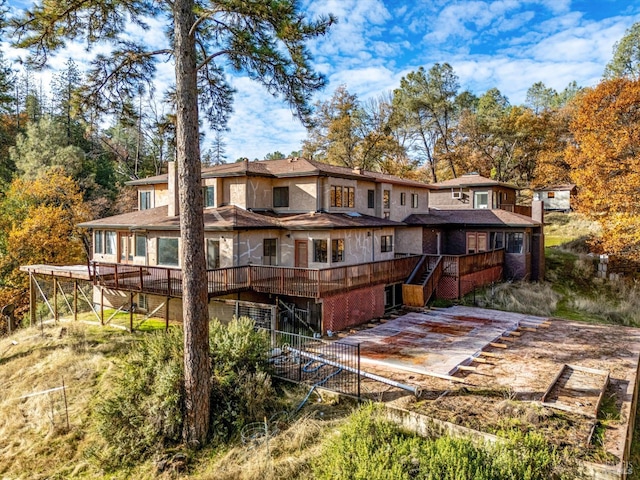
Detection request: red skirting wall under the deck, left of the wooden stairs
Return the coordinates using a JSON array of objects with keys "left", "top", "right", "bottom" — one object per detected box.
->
[{"left": 322, "top": 285, "right": 384, "bottom": 333}]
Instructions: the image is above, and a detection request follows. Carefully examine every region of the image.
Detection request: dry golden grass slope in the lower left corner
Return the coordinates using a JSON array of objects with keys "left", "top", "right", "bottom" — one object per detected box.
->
[{"left": 0, "top": 324, "right": 132, "bottom": 479}]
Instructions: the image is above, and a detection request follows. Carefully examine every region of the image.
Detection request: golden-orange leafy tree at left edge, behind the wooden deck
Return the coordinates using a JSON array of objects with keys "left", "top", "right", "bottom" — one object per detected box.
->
[{"left": 0, "top": 168, "right": 91, "bottom": 307}]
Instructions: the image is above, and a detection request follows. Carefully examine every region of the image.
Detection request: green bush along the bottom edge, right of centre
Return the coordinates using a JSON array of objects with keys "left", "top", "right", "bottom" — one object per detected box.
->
[{"left": 313, "top": 405, "right": 561, "bottom": 480}]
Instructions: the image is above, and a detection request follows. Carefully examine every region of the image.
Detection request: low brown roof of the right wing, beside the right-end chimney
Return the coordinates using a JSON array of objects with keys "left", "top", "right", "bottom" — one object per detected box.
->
[{"left": 404, "top": 209, "right": 541, "bottom": 227}]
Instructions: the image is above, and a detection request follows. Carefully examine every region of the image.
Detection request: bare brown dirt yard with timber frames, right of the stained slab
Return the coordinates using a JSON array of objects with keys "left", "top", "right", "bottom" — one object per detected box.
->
[{"left": 340, "top": 307, "right": 640, "bottom": 464}]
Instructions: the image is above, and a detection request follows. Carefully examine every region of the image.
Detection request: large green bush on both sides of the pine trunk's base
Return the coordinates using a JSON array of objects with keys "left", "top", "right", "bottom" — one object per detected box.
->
[{"left": 89, "top": 318, "right": 277, "bottom": 468}]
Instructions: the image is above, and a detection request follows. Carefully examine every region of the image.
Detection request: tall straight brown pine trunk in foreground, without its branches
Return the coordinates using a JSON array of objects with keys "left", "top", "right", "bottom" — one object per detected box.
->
[{"left": 174, "top": 0, "right": 210, "bottom": 445}]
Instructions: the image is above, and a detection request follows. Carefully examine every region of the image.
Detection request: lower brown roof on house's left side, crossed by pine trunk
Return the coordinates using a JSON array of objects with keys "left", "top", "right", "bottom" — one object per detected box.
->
[{"left": 79, "top": 205, "right": 280, "bottom": 230}]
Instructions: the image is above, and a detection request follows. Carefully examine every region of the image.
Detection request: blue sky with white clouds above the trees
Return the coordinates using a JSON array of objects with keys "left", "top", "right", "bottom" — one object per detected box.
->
[{"left": 2, "top": 0, "right": 640, "bottom": 161}]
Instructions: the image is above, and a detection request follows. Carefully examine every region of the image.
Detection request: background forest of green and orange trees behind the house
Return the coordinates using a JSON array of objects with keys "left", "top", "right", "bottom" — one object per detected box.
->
[{"left": 0, "top": 20, "right": 640, "bottom": 316}]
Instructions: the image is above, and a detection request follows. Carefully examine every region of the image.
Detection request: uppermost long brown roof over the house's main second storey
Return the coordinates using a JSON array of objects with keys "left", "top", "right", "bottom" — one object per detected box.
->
[{"left": 126, "top": 158, "right": 431, "bottom": 189}]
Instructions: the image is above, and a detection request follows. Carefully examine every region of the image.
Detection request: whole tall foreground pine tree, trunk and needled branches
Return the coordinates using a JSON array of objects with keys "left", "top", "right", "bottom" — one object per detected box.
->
[{"left": 13, "top": 0, "right": 333, "bottom": 444}]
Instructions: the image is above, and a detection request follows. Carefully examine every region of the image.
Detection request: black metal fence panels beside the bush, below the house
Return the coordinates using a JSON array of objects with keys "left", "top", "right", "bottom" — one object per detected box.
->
[{"left": 270, "top": 330, "right": 360, "bottom": 398}]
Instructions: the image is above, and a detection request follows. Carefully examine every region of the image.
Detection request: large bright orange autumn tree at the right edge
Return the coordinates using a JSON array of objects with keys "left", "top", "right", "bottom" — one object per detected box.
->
[{"left": 566, "top": 78, "right": 640, "bottom": 261}]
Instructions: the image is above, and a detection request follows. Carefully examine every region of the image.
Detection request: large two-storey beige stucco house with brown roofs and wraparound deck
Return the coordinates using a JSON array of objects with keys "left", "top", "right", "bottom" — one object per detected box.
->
[{"left": 20, "top": 158, "right": 544, "bottom": 332}]
